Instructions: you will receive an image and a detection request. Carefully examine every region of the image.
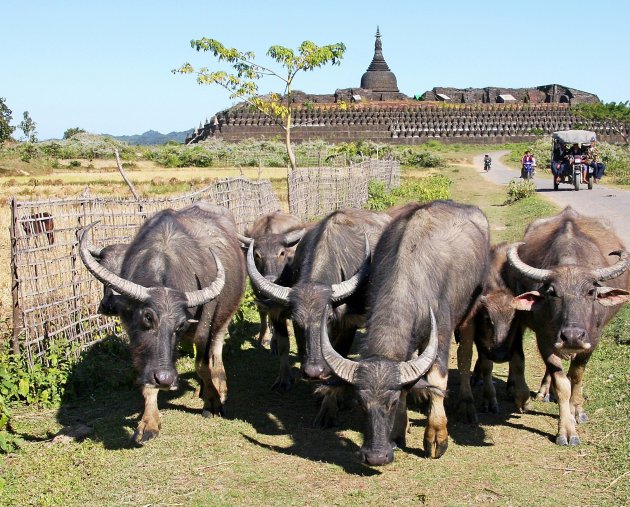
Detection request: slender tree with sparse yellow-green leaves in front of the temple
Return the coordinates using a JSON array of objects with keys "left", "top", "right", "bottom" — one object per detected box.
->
[{"left": 173, "top": 38, "right": 346, "bottom": 169}]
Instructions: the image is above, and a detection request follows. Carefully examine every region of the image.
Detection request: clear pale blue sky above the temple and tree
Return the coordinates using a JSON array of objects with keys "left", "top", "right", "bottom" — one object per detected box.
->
[{"left": 0, "top": 0, "right": 630, "bottom": 139}]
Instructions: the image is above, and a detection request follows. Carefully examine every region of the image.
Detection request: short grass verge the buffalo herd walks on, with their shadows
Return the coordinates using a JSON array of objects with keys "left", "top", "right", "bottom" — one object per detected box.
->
[{"left": 0, "top": 157, "right": 630, "bottom": 507}]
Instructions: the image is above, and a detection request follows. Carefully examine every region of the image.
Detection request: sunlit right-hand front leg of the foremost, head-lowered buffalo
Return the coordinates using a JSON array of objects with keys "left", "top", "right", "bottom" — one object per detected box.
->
[{"left": 424, "top": 358, "right": 448, "bottom": 458}]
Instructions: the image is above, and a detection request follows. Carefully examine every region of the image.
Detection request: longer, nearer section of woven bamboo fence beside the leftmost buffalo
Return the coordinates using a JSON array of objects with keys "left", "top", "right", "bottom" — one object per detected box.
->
[{"left": 10, "top": 177, "right": 280, "bottom": 365}]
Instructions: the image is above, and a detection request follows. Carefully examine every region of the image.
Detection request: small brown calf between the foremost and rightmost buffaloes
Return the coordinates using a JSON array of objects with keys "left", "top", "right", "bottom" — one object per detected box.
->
[{"left": 456, "top": 243, "right": 529, "bottom": 422}]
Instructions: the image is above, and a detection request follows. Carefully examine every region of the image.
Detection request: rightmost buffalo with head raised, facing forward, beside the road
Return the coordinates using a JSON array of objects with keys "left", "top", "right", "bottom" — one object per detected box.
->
[{"left": 507, "top": 207, "right": 630, "bottom": 445}]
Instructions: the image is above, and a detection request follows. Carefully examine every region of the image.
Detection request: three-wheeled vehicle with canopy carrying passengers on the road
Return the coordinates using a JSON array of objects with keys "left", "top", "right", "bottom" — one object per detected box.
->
[{"left": 551, "top": 130, "right": 597, "bottom": 190}]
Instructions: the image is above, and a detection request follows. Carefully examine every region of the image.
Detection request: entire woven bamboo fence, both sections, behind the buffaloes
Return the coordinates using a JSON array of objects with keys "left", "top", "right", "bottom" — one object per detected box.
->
[{"left": 10, "top": 160, "right": 400, "bottom": 365}]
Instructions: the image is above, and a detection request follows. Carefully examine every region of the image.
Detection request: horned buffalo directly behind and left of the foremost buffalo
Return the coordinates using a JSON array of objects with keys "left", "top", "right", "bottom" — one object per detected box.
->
[{"left": 247, "top": 209, "right": 391, "bottom": 420}]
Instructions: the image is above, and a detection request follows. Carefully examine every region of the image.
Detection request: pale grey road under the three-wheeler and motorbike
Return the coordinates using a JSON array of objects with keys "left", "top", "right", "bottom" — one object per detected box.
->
[{"left": 473, "top": 151, "right": 630, "bottom": 246}]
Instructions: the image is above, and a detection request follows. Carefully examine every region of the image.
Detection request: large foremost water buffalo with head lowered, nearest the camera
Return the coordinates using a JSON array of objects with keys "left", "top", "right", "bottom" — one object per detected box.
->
[{"left": 321, "top": 201, "right": 490, "bottom": 465}]
